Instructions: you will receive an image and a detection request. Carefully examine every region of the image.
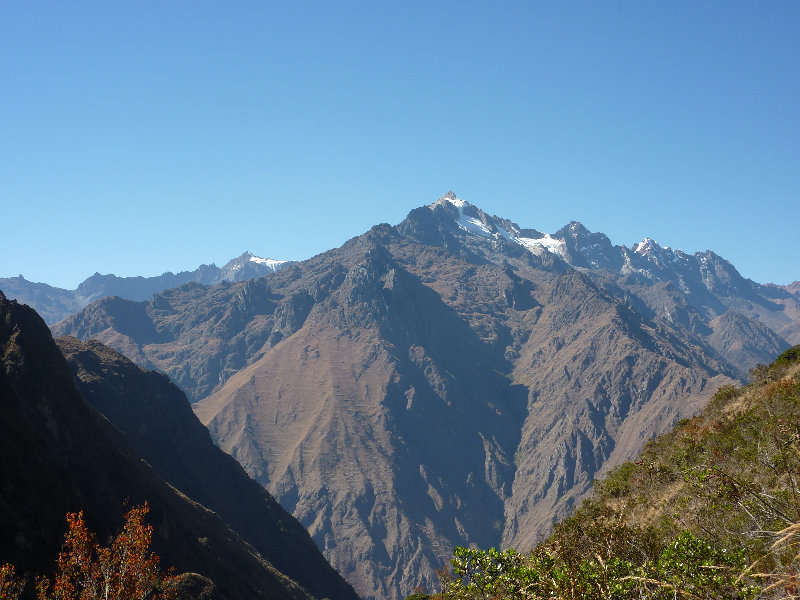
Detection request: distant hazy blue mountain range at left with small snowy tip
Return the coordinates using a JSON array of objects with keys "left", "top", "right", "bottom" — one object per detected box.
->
[{"left": 0, "top": 251, "right": 292, "bottom": 325}]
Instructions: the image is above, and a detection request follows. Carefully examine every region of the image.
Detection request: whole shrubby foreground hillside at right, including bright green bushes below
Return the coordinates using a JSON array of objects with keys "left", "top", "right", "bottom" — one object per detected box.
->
[{"left": 434, "top": 346, "right": 800, "bottom": 600}]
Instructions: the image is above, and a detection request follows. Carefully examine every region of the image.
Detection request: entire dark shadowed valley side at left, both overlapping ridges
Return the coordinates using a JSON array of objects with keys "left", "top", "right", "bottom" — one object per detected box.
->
[{"left": 0, "top": 294, "right": 356, "bottom": 600}]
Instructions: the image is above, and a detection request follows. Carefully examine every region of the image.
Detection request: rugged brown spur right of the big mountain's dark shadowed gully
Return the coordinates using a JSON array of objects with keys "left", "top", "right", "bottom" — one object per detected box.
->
[{"left": 503, "top": 271, "right": 732, "bottom": 548}]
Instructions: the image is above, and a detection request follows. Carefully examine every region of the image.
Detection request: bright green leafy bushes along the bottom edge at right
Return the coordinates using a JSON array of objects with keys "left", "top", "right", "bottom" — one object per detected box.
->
[{"left": 440, "top": 528, "right": 758, "bottom": 600}]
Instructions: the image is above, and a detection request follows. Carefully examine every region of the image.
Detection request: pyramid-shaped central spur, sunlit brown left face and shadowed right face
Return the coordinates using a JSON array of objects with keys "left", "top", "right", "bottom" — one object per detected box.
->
[{"left": 196, "top": 246, "right": 524, "bottom": 597}]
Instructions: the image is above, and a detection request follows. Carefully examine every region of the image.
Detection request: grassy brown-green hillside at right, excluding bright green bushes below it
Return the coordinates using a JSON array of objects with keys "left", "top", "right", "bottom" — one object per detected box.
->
[{"left": 545, "top": 346, "right": 800, "bottom": 598}]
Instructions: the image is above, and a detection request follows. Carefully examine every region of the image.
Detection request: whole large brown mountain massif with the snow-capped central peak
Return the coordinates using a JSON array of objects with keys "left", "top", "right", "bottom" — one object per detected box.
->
[{"left": 55, "top": 195, "right": 800, "bottom": 597}]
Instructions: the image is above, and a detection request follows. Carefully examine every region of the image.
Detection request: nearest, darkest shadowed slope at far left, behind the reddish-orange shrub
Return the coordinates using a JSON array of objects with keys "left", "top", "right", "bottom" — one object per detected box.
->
[{"left": 0, "top": 295, "right": 354, "bottom": 600}]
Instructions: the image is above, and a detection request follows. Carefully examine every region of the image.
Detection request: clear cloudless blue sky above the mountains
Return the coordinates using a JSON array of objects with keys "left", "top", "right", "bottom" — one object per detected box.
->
[{"left": 0, "top": 0, "right": 800, "bottom": 288}]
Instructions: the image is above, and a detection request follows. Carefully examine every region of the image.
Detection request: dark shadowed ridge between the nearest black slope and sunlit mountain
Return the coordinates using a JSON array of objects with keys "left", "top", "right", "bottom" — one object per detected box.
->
[{"left": 56, "top": 338, "right": 355, "bottom": 600}]
